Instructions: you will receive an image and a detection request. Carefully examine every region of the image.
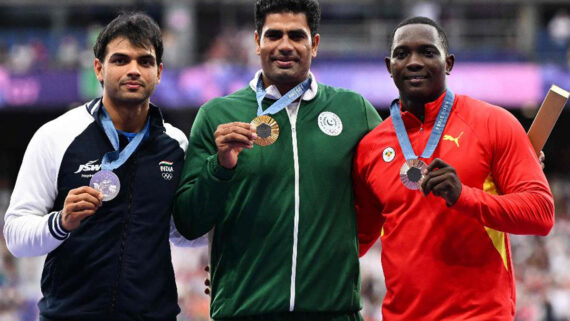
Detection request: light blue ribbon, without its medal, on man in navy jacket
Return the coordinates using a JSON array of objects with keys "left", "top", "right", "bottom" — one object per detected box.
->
[{"left": 101, "top": 105, "right": 150, "bottom": 171}]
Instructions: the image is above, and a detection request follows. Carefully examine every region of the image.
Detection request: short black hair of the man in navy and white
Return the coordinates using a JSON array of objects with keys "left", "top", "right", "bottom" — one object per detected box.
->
[{"left": 93, "top": 12, "right": 164, "bottom": 65}]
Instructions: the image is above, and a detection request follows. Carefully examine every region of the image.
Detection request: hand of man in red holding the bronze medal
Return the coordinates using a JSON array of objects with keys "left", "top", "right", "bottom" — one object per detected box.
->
[{"left": 421, "top": 158, "right": 462, "bottom": 206}]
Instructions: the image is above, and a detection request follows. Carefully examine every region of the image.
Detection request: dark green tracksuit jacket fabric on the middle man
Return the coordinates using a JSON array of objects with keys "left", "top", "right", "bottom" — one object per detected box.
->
[{"left": 174, "top": 84, "right": 381, "bottom": 318}]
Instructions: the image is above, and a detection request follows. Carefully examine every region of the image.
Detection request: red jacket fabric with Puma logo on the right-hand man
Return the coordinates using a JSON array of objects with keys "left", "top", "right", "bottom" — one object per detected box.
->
[{"left": 353, "top": 91, "right": 554, "bottom": 321}]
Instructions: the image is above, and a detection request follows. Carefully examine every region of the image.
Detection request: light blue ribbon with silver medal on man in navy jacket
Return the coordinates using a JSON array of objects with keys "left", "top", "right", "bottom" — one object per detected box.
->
[{"left": 89, "top": 106, "right": 150, "bottom": 201}]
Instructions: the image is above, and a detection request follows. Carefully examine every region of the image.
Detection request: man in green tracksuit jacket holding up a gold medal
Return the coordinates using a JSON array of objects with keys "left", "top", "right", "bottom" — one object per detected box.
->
[{"left": 174, "top": 0, "right": 381, "bottom": 321}]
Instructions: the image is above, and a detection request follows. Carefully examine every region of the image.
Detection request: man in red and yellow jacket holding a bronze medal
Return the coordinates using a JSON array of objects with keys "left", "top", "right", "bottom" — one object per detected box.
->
[{"left": 353, "top": 17, "right": 554, "bottom": 321}]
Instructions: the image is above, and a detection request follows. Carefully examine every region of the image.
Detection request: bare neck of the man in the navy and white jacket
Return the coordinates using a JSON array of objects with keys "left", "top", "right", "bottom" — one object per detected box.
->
[{"left": 103, "top": 97, "right": 149, "bottom": 133}]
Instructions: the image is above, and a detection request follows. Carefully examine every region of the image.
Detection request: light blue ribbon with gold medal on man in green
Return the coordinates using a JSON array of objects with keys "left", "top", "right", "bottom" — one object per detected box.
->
[{"left": 251, "top": 75, "right": 311, "bottom": 146}]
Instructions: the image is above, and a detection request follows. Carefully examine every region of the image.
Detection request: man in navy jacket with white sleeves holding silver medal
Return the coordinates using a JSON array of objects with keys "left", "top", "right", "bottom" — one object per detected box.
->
[{"left": 4, "top": 13, "right": 199, "bottom": 321}]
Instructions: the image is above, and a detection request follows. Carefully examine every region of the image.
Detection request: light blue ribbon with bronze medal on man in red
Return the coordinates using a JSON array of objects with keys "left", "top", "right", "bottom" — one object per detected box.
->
[{"left": 390, "top": 89, "right": 455, "bottom": 190}]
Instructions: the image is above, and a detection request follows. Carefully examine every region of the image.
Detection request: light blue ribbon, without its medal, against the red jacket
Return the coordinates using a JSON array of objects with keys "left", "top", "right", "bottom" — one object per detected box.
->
[{"left": 390, "top": 89, "right": 455, "bottom": 161}]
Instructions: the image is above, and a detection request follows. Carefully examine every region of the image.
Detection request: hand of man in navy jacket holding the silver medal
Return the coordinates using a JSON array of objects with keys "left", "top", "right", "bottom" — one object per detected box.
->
[{"left": 61, "top": 186, "right": 103, "bottom": 232}]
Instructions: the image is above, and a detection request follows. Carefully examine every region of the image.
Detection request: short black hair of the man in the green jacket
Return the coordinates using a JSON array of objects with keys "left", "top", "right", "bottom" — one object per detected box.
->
[{"left": 254, "top": 0, "right": 321, "bottom": 38}]
